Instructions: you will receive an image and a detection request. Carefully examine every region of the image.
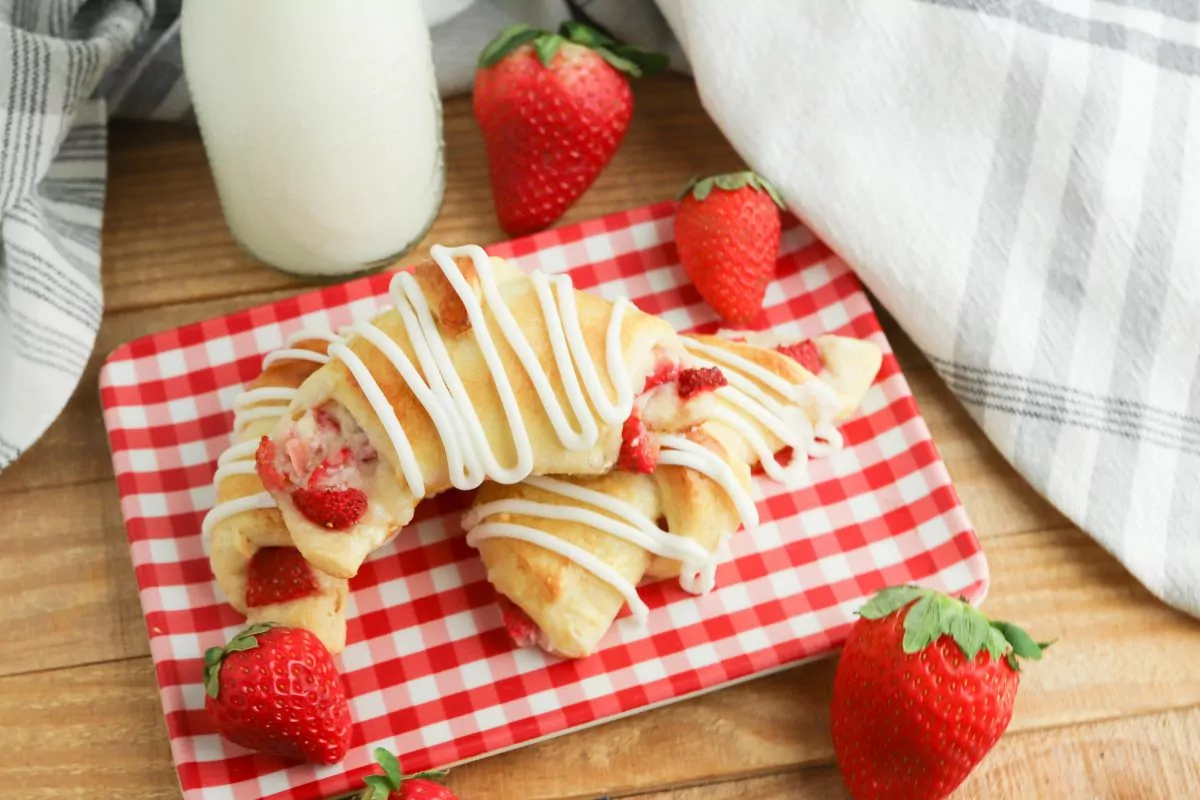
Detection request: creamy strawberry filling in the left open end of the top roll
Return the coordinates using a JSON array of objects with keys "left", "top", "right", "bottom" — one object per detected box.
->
[{"left": 256, "top": 403, "right": 379, "bottom": 530}]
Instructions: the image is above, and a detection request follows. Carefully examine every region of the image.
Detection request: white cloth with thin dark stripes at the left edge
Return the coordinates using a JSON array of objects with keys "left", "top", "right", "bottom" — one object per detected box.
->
[{"left": 0, "top": 0, "right": 152, "bottom": 468}]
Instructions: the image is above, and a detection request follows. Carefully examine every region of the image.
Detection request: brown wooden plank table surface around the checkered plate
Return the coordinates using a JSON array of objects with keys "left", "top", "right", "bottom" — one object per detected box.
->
[{"left": 0, "top": 71, "right": 1200, "bottom": 800}]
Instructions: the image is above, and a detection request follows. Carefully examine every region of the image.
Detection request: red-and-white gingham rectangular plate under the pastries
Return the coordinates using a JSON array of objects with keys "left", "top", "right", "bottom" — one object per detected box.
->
[{"left": 101, "top": 204, "right": 988, "bottom": 800}]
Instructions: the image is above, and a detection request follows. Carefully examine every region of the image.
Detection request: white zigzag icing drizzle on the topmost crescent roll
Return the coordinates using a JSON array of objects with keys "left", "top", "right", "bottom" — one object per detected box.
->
[{"left": 329, "top": 245, "right": 634, "bottom": 499}]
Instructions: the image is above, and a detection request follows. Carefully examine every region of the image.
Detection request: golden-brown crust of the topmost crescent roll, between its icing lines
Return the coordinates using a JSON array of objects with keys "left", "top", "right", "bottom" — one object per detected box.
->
[{"left": 275, "top": 258, "right": 685, "bottom": 577}]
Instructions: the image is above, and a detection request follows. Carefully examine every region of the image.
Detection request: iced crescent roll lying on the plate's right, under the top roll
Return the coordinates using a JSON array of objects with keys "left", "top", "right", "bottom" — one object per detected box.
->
[{"left": 463, "top": 336, "right": 882, "bottom": 657}]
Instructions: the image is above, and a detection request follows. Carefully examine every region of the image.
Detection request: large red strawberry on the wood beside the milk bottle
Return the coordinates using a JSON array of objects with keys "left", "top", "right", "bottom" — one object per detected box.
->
[{"left": 474, "top": 22, "right": 667, "bottom": 235}]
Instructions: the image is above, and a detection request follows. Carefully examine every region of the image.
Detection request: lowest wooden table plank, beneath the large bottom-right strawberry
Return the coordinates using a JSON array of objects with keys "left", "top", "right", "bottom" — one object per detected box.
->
[{"left": 624, "top": 708, "right": 1200, "bottom": 800}]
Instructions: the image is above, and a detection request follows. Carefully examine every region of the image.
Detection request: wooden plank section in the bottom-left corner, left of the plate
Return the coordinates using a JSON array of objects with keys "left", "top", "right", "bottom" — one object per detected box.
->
[{"left": 0, "top": 658, "right": 180, "bottom": 800}]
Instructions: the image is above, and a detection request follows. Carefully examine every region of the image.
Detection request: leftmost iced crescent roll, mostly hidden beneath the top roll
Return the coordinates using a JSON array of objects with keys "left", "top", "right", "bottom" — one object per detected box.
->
[{"left": 203, "top": 331, "right": 347, "bottom": 654}]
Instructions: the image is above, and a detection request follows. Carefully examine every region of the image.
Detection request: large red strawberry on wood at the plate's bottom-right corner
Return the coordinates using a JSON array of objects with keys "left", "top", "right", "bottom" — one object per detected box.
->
[{"left": 830, "top": 587, "right": 1049, "bottom": 800}]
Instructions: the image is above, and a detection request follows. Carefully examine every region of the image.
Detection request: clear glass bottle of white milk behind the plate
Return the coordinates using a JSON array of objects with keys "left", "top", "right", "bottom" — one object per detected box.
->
[{"left": 181, "top": 0, "right": 445, "bottom": 275}]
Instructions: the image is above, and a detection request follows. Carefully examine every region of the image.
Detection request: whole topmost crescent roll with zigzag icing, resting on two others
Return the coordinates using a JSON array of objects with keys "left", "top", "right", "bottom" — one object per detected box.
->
[{"left": 257, "top": 246, "right": 719, "bottom": 578}]
